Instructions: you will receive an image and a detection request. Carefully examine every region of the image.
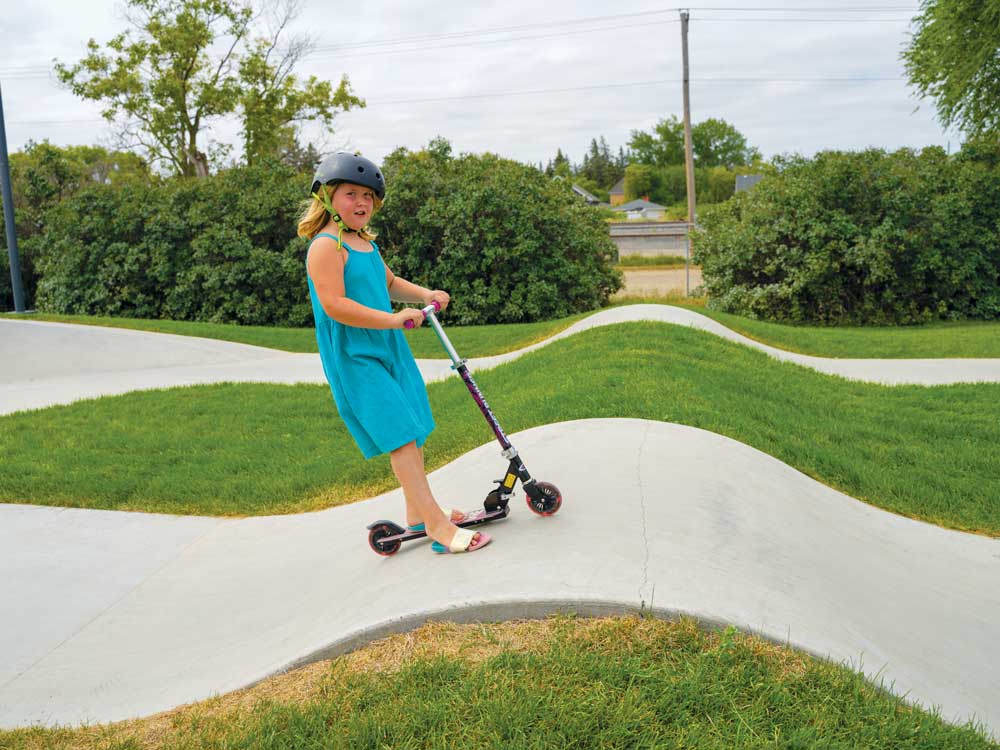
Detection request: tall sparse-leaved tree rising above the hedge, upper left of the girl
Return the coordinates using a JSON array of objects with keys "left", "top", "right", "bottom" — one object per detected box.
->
[{"left": 55, "top": 0, "right": 364, "bottom": 177}]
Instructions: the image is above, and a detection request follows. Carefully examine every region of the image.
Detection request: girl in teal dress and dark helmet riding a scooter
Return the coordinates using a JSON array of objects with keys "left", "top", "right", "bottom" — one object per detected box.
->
[{"left": 298, "top": 152, "right": 491, "bottom": 552}]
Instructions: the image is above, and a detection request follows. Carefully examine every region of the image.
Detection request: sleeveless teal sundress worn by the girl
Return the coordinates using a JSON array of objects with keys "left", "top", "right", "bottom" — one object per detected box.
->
[{"left": 306, "top": 233, "right": 434, "bottom": 458}]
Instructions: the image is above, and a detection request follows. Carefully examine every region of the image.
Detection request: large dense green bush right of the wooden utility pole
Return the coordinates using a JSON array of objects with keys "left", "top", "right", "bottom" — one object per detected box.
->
[{"left": 694, "top": 144, "right": 1000, "bottom": 324}]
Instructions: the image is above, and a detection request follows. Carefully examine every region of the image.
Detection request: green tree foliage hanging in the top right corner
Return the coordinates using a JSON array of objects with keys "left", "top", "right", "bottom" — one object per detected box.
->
[{"left": 902, "top": 0, "right": 1000, "bottom": 138}]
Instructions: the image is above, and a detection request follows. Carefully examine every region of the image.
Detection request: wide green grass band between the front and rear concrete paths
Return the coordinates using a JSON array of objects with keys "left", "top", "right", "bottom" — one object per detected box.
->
[{"left": 0, "top": 323, "right": 1000, "bottom": 535}]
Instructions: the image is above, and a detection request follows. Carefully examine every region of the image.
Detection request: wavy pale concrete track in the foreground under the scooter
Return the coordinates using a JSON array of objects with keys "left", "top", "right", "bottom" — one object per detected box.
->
[{"left": 0, "top": 419, "right": 1000, "bottom": 731}]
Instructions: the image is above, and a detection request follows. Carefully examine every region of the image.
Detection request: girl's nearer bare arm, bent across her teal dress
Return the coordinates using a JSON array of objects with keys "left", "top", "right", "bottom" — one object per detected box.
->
[{"left": 307, "top": 237, "right": 424, "bottom": 329}]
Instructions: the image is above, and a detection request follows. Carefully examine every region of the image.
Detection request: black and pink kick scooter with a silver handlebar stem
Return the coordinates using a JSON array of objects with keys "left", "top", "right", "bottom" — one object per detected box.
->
[{"left": 368, "top": 302, "right": 562, "bottom": 557}]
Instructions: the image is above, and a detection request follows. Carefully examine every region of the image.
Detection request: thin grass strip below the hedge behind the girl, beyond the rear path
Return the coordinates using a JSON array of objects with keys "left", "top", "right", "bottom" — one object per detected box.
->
[{"left": 0, "top": 313, "right": 591, "bottom": 359}]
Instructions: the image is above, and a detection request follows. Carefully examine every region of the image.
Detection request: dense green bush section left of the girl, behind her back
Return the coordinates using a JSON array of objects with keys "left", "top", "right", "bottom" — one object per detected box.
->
[{"left": 38, "top": 164, "right": 312, "bottom": 326}]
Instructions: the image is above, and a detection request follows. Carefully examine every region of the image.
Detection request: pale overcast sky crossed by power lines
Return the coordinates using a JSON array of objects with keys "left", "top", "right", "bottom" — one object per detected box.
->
[{"left": 0, "top": 0, "right": 960, "bottom": 170}]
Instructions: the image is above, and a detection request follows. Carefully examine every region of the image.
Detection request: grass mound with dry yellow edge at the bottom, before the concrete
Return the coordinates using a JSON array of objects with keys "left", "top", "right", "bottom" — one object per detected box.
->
[{"left": 0, "top": 617, "right": 997, "bottom": 750}]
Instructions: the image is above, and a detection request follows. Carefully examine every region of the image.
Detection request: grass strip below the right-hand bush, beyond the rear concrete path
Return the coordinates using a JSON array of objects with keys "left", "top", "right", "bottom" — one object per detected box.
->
[{"left": 699, "top": 308, "right": 1000, "bottom": 359}]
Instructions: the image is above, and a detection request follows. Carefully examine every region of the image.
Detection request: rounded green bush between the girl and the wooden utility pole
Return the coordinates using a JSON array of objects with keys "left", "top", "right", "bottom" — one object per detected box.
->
[{"left": 373, "top": 139, "right": 622, "bottom": 324}]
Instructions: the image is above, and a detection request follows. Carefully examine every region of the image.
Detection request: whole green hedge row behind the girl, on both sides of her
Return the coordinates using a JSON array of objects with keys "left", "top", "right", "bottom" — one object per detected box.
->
[{"left": 8, "top": 142, "right": 621, "bottom": 326}]
